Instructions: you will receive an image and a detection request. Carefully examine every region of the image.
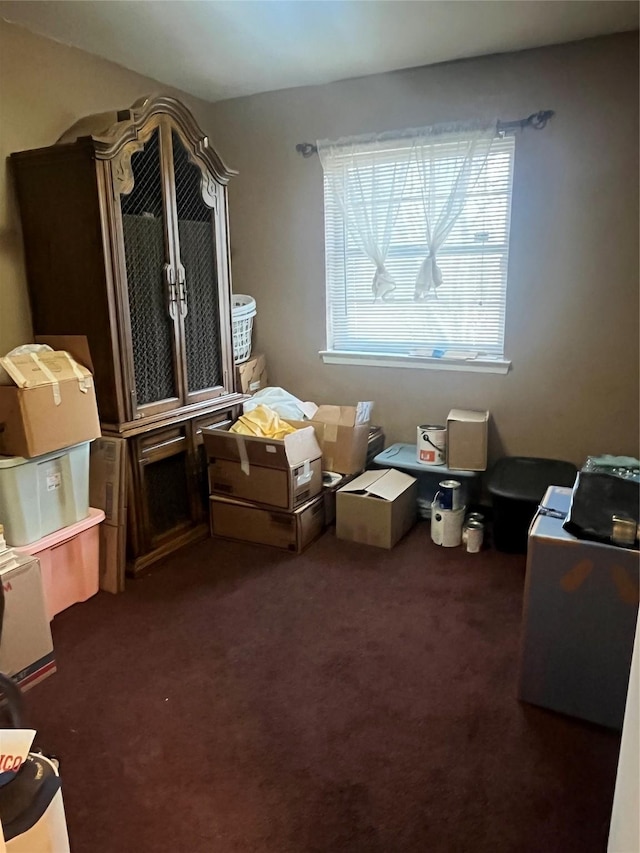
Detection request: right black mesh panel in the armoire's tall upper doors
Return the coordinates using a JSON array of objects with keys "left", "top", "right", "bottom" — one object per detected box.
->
[{"left": 173, "top": 132, "right": 222, "bottom": 392}]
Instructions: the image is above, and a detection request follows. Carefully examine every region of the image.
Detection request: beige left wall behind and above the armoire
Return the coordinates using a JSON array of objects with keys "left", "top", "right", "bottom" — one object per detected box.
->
[{"left": 0, "top": 20, "right": 215, "bottom": 355}]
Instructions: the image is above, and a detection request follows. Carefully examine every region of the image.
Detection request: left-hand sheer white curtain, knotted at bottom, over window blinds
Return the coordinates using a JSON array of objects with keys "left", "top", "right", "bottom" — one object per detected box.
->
[{"left": 318, "top": 137, "right": 411, "bottom": 300}]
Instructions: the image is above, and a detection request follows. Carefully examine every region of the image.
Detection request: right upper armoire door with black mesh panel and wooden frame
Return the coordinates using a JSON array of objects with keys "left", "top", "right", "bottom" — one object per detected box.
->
[{"left": 171, "top": 130, "right": 230, "bottom": 403}]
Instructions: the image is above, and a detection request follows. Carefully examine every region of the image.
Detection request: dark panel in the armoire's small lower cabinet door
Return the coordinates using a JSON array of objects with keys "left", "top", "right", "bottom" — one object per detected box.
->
[{"left": 145, "top": 453, "right": 191, "bottom": 537}]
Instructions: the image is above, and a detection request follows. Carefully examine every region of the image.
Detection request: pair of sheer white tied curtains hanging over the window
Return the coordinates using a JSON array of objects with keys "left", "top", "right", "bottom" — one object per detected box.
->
[{"left": 317, "top": 122, "right": 496, "bottom": 301}]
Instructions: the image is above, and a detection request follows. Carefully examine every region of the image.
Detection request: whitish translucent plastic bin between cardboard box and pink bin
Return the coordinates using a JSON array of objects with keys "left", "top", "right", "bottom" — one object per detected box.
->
[{"left": 0, "top": 441, "right": 90, "bottom": 545}]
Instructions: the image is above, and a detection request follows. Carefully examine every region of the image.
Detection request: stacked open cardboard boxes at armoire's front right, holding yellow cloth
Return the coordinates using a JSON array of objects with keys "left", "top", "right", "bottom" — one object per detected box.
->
[{"left": 203, "top": 403, "right": 371, "bottom": 553}]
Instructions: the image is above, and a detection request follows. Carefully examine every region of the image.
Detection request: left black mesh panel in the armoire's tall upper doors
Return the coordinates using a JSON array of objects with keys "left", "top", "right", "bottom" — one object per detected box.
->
[{"left": 120, "top": 131, "right": 177, "bottom": 405}]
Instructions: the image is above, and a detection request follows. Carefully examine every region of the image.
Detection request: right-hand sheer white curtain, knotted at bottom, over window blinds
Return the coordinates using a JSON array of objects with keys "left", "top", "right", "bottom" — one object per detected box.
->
[{"left": 413, "top": 123, "right": 496, "bottom": 299}]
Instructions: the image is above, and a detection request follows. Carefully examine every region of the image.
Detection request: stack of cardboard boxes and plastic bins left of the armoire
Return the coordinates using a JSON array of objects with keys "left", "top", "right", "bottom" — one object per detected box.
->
[{"left": 0, "top": 338, "right": 103, "bottom": 686}]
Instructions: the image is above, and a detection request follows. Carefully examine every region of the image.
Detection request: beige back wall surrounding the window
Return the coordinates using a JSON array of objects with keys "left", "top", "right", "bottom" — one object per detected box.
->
[{"left": 208, "top": 34, "right": 639, "bottom": 463}]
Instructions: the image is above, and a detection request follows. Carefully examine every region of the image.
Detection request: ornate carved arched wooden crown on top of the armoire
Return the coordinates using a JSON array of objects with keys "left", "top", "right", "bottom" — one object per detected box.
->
[{"left": 57, "top": 95, "right": 238, "bottom": 184}]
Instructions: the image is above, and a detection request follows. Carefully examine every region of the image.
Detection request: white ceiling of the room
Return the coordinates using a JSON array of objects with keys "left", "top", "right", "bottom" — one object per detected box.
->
[{"left": 0, "top": 0, "right": 639, "bottom": 101}]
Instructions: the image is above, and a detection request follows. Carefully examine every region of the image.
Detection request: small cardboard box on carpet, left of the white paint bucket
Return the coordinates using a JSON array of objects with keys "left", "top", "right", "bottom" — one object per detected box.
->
[{"left": 336, "top": 469, "right": 418, "bottom": 548}]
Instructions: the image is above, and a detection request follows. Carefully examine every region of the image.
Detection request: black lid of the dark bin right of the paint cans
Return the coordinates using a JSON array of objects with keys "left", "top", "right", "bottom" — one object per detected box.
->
[{"left": 487, "top": 456, "right": 578, "bottom": 502}]
